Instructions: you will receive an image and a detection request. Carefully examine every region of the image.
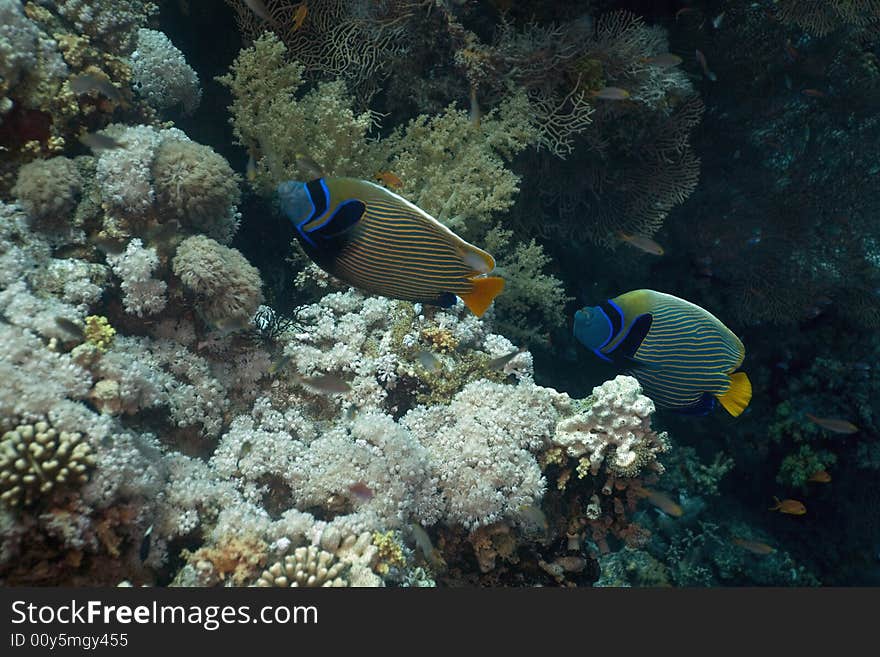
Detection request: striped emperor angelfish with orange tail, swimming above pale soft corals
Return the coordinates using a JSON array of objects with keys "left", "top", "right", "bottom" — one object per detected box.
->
[{"left": 278, "top": 178, "right": 504, "bottom": 317}]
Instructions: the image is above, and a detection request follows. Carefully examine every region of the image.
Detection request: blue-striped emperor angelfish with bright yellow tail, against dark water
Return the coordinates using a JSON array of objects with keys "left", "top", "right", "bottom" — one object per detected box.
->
[{"left": 574, "top": 290, "right": 752, "bottom": 417}]
